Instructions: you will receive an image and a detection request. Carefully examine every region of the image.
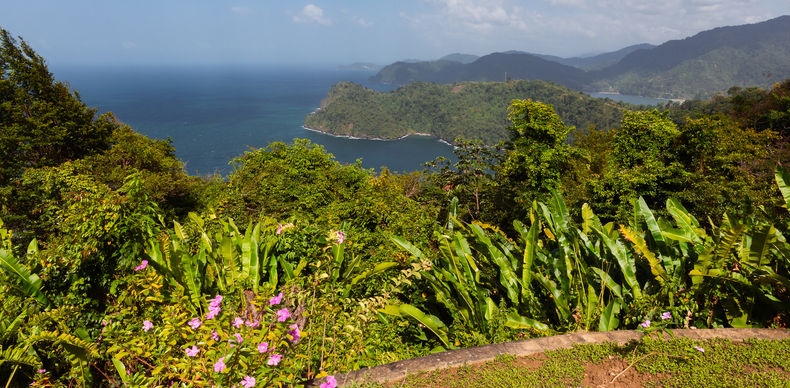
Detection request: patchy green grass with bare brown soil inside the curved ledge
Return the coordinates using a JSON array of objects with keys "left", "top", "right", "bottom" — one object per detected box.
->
[{"left": 350, "top": 337, "right": 790, "bottom": 388}]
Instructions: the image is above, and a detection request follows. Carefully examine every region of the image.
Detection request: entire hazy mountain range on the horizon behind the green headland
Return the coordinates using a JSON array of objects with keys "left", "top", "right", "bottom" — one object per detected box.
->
[{"left": 372, "top": 16, "right": 790, "bottom": 99}]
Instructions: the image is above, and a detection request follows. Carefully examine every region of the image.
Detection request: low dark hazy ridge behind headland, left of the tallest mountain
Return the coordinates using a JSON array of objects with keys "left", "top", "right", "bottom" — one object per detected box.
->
[{"left": 371, "top": 53, "right": 587, "bottom": 89}]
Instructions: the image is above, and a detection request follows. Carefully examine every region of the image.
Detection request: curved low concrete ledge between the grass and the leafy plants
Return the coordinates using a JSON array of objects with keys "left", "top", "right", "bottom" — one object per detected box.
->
[{"left": 307, "top": 329, "right": 790, "bottom": 387}]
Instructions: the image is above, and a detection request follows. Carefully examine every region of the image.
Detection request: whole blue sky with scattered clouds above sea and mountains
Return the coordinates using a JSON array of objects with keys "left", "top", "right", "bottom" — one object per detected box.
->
[{"left": 0, "top": 0, "right": 790, "bottom": 65}]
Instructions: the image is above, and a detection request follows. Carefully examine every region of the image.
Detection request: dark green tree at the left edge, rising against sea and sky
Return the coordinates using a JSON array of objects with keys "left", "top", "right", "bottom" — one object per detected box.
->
[{"left": 0, "top": 28, "right": 115, "bottom": 186}]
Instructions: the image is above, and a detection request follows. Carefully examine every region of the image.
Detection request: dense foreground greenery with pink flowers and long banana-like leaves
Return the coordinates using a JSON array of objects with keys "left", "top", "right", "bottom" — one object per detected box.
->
[{"left": 0, "top": 31, "right": 790, "bottom": 387}]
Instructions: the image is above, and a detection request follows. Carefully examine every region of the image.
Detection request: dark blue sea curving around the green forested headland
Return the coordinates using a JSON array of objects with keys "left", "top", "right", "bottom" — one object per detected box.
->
[{"left": 53, "top": 67, "right": 452, "bottom": 175}]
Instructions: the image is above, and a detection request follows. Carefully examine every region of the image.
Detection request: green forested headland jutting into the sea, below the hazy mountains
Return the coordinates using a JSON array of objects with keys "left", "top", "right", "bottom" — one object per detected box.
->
[{"left": 305, "top": 80, "right": 644, "bottom": 144}]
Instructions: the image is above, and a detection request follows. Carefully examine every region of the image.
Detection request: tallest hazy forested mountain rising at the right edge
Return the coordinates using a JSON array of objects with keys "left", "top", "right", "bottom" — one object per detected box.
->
[{"left": 586, "top": 16, "right": 790, "bottom": 98}]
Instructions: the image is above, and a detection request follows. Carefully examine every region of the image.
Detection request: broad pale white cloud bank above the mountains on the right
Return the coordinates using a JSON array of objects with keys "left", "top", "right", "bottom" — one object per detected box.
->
[{"left": 408, "top": 0, "right": 790, "bottom": 56}]
